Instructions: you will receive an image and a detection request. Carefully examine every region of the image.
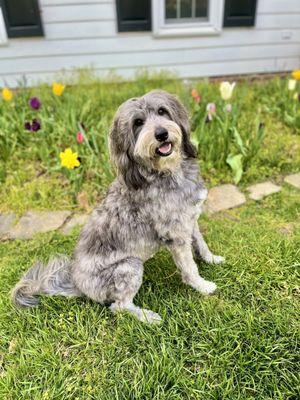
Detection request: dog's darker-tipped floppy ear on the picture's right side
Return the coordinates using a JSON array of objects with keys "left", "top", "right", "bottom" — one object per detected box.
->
[{"left": 169, "top": 95, "right": 197, "bottom": 158}]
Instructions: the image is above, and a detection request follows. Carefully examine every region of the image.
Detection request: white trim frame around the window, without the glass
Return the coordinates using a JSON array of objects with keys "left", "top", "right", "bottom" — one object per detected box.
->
[{"left": 152, "top": 0, "right": 224, "bottom": 37}]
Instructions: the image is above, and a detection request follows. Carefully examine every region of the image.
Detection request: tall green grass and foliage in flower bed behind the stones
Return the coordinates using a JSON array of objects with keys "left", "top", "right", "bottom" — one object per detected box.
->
[{"left": 0, "top": 73, "right": 300, "bottom": 215}]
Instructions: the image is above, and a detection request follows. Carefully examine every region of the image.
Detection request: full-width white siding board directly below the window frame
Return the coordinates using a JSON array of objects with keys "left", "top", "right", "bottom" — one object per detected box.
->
[{"left": 1, "top": 28, "right": 300, "bottom": 59}]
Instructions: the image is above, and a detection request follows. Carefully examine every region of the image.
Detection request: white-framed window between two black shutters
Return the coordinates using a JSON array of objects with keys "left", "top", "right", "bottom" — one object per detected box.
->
[{"left": 153, "top": 0, "right": 224, "bottom": 36}]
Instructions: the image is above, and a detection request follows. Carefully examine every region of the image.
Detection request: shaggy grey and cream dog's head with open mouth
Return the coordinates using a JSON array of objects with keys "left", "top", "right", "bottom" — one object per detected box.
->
[{"left": 110, "top": 90, "right": 197, "bottom": 189}]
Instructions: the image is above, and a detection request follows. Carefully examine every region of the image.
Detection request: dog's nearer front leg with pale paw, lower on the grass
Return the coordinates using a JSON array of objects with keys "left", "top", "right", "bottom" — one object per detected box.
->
[{"left": 170, "top": 244, "right": 217, "bottom": 294}]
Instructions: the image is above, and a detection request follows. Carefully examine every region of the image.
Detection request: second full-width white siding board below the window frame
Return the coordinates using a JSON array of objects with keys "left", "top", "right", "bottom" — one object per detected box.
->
[{"left": 0, "top": 44, "right": 300, "bottom": 75}]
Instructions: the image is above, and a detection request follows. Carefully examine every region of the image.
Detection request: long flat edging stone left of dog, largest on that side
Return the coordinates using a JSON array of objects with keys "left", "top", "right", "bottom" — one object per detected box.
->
[{"left": 8, "top": 211, "right": 71, "bottom": 239}]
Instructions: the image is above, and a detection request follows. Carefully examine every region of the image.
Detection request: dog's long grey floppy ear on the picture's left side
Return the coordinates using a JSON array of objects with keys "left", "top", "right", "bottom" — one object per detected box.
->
[{"left": 109, "top": 110, "right": 147, "bottom": 189}]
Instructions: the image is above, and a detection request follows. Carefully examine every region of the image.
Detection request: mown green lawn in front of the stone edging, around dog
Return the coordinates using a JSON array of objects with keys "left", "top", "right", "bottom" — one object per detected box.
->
[{"left": 0, "top": 185, "right": 300, "bottom": 400}]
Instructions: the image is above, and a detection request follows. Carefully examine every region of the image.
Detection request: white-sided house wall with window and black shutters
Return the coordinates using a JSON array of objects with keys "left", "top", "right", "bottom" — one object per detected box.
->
[{"left": 0, "top": 0, "right": 300, "bottom": 86}]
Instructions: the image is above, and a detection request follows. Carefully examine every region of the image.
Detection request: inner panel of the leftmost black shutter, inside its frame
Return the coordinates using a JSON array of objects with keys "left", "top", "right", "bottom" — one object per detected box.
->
[{"left": 5, "top": 0, "right": 36, "bottom": 27}]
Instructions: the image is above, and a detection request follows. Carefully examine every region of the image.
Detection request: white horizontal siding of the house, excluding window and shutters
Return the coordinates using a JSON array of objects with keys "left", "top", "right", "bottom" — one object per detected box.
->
[{"left": 0, "top": 0, "right": 300, "bottom": 86}]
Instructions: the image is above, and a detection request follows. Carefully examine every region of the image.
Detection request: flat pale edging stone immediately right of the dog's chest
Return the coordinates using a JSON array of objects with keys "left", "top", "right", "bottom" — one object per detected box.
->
[{"left": 204, "top": 184, "right": 246, "bottom": 213}]
